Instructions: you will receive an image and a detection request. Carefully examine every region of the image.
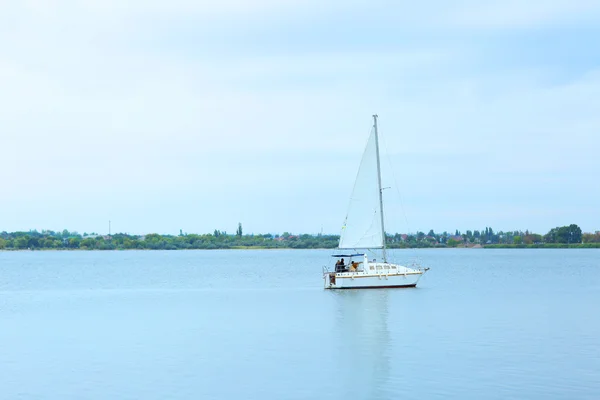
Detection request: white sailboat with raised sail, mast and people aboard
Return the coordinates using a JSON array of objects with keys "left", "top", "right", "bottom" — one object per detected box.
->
[{"left": 323, "top": 115, "right": 429, "bottom": 289}]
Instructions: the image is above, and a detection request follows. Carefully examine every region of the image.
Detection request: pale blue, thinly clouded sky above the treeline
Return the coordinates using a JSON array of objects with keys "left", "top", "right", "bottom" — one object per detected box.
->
[{"left": 0, "top": 0, "right": 600, "bottom": 234}]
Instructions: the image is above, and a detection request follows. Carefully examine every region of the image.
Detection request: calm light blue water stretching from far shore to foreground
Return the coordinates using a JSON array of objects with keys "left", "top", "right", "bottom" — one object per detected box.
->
[{"left": 0, "top": 249, "right": 600, "bottom": 400}]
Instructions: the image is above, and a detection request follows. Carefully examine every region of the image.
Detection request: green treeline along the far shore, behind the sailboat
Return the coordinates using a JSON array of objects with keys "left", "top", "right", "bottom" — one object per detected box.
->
[{"left": 0, "top": 224, "right": 600, "bottom": 250}]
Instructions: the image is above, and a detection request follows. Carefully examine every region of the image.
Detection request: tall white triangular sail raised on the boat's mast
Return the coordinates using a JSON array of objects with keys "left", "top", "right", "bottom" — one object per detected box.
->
[{"left": 338, "top": 129, "right": 383, "bottom": 249}]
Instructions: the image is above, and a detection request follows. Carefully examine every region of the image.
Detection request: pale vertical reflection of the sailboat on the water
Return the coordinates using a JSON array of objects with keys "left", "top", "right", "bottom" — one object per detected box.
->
[{"left": 332, "top": 289, "right": 393, "bottom": 399}]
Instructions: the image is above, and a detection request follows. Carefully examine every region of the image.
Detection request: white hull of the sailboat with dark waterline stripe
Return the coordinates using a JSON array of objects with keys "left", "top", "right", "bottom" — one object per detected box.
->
[{"left": 323, "top": 263, "right": 425, "bottom": 289}]
